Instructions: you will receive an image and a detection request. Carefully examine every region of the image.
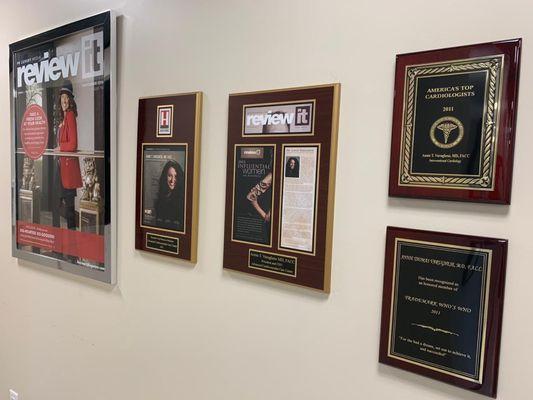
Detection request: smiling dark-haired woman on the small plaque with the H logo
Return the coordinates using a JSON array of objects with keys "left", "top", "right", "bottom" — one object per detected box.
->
[{"left": 154, "top": 160, "right": 185, "bottom": 231}]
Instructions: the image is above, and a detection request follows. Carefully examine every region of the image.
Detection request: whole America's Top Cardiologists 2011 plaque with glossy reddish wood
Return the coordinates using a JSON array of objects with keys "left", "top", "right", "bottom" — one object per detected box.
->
[{"left": 389, "top": 39, "right": 521, "bottom": 204}]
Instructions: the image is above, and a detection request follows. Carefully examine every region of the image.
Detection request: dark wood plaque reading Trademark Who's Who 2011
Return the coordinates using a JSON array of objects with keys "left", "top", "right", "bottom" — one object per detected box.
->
[{"left": 379, "top": 227, "right": 507, "bottom": 397}]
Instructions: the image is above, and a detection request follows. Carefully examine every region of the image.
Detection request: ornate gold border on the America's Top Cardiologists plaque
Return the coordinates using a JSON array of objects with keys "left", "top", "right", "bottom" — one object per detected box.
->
[{"left": 398, "top": 54, "right": 504, "bottom": 191}]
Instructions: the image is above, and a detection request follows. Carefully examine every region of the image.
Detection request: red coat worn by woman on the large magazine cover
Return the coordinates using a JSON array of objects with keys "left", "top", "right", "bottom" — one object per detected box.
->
[{"left": 59, "top": 110, "right": 82, "bottom": 189}]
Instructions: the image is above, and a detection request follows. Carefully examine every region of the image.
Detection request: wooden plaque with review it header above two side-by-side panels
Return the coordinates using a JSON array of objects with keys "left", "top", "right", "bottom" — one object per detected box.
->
[{"left": 224, "top": 84, "right": 340, "bottom": 293}]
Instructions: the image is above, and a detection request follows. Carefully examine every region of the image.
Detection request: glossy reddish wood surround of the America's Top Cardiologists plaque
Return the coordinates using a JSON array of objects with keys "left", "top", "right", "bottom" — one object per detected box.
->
[{"left": 389, "top": 39, "right": 522, "bottom": 204}]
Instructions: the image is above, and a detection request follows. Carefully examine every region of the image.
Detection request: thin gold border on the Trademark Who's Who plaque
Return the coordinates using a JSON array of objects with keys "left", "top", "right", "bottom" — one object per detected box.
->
[{"left": 387, "top": 237, "right": 492, "bottom": 384}]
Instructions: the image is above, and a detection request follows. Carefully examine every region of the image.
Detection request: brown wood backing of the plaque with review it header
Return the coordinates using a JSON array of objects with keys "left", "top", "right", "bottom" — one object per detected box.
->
[{"left": 223, "top": 84, "right": 339, "bottom": 292}]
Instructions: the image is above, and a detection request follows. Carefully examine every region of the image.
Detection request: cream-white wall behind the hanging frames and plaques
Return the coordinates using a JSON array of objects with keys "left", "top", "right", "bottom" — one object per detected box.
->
[{"left": 0, "top": 0, "right": 533, "bottom": 400}]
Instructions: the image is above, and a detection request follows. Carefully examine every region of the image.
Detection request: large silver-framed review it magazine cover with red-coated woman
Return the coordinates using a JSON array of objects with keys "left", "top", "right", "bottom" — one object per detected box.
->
[{"left": 9, "top": 11, "right": 116, "bottom": 284}]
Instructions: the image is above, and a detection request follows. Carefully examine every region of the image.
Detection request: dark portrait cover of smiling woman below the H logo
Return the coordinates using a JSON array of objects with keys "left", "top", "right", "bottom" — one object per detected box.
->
[{"left": 142, "top": 145, "right": 186, "bottom": 233}]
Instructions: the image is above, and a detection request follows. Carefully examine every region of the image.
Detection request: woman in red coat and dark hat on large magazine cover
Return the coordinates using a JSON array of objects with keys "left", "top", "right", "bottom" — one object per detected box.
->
[{"left": 56, "top": 80, "right": 82, "bottom": 229}]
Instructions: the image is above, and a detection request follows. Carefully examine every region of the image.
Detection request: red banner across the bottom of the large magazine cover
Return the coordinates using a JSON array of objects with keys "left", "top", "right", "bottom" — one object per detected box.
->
[{"left": 17, "top": 221, "right": 105, "bottom": 263}]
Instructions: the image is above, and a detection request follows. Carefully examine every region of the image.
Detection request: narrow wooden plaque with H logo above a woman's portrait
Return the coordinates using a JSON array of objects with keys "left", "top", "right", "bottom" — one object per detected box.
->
[{"left": 135, "top": 92, "right": 202, "bottom": 262}]
